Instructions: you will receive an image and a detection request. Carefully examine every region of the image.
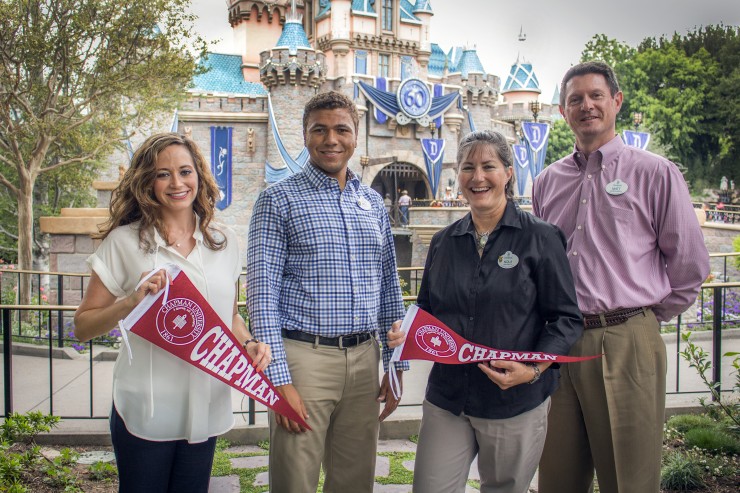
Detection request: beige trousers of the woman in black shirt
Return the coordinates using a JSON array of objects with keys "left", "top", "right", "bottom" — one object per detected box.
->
[{"left": 414, "top": 399, "right": 550, "bottom": 493}]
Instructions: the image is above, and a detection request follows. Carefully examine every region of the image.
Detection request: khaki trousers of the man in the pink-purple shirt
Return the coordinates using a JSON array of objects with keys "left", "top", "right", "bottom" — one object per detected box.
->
[{"left": 538, "top": 310, "right": 666, "bottom": 493}]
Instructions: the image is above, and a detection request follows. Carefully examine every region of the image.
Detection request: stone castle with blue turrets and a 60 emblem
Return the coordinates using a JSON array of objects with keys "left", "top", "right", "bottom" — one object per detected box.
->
[{"left": 44, "top": 0, "right": 559, "bottom": 270}]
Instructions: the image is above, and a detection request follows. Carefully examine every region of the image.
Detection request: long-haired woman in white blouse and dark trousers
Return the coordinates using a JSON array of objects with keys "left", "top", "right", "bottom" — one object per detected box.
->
[{"left": 75, "top": 133, "right": 270, "bottom": 493}]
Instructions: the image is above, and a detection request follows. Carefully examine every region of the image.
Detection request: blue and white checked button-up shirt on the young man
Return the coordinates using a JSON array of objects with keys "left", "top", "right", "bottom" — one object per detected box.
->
[{"left": 247, "top": 163, "right": 404, "bottom": 385}]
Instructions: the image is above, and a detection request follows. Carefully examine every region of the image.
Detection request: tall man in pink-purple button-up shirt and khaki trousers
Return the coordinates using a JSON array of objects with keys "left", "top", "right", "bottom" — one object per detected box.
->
[{"left": 532, "top": 62, "right": 709, "bottom": 493}]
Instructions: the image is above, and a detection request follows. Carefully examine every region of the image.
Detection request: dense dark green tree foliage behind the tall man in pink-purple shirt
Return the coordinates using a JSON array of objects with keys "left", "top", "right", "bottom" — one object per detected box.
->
[{"left": 582, "top": 25, "right": 740, "bottom": 187}]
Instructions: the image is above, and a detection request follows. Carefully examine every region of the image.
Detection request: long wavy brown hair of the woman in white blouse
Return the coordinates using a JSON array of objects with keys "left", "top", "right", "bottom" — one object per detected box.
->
[{"left": 94, "top": 132, "right": 226, "bottom": 251}]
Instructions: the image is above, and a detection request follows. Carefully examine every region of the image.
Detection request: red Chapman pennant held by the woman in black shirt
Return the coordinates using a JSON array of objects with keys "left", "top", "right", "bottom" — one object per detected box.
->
[{"left": 394, "top": 305, "right": 601, "bottom": 365}]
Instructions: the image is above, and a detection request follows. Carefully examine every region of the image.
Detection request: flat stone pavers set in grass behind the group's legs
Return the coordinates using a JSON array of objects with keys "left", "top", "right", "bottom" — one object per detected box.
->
[{"left": 209, "top": 440, "right": 537, "bottom": 493}]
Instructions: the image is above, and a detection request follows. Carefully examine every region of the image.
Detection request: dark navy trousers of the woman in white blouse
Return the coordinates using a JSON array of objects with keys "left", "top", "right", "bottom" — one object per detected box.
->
[{"left": 110, "top": 406, "right": 216, "bottom": 493}]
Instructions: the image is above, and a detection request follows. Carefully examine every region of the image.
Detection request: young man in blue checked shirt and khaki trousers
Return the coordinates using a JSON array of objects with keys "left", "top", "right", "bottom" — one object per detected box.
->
[{"left": 247, "top": 92, "right": 404, "bottom": 493}]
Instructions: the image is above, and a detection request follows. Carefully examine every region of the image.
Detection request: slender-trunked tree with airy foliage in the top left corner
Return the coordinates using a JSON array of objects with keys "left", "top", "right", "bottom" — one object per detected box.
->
[{"left": 0, "top": 0, "right": 206, "bottom": 278}]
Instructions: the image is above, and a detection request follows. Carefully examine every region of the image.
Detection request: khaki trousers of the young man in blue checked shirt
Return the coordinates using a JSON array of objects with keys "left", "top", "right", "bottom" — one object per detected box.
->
[{"left": 270, "top": 339, "right": 380, "bottom": 493}]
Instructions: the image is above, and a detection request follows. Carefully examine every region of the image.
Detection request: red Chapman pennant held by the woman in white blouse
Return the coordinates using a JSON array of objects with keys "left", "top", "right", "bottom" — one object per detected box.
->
[{"left": 122, "top": 264, "right": 311, "bottom": 430}]
